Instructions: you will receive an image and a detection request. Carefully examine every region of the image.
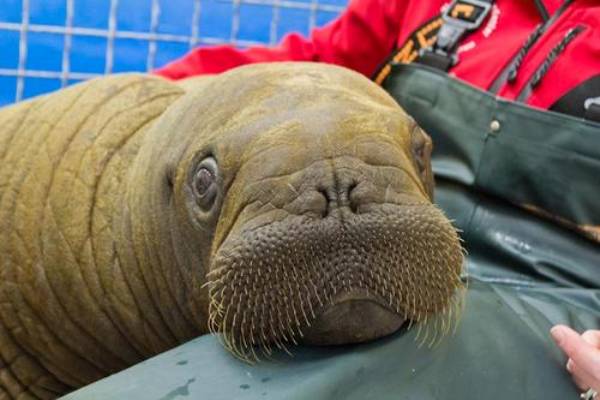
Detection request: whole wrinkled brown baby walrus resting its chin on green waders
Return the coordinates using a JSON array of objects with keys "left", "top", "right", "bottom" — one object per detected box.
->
[{"left": 0, "top": 63, "right": 462, "bottom": 398}]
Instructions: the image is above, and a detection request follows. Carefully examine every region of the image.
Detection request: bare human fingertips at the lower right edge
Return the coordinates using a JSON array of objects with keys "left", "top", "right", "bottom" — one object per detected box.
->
[{"left": 550, "top": 325, "right": 600, "bottom": 400}]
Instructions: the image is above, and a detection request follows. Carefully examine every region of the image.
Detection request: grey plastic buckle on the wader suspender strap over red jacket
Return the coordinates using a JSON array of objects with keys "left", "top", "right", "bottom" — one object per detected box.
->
[{"left": 419, "top": 0, "right": 494, "bottom": 71}]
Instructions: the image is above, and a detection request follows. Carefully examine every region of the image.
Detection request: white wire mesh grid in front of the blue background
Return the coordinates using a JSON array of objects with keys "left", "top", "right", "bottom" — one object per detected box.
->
[{"left": 0, "top": 0, "right": 344, "bottom": 102}]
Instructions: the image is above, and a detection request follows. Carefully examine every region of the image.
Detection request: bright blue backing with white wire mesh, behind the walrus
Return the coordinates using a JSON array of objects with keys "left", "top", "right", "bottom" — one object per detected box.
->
[{"left": 0, "top": 0, "right": 347, "bottom": 106}]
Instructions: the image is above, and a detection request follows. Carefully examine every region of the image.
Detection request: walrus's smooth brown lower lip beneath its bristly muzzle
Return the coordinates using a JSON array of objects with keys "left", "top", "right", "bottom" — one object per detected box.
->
[{"left": 302, "top": 292, "right": 406, "bottom": 346}]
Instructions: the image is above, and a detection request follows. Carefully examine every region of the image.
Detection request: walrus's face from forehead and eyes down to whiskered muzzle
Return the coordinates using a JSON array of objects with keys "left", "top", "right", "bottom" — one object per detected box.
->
[{"left": 169, "top": 64, "right": 462, "bottom": 358}]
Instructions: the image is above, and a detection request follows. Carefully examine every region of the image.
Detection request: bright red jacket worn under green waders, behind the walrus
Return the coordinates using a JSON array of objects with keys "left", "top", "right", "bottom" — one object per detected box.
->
[{"left": 156, "top": 0, "right": 600, "bottom": 112}]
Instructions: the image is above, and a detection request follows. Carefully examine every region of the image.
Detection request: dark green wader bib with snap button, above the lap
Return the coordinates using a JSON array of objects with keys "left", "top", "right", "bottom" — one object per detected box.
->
[{"left": 384, "top": 64, "right": 600, "bottom": 290}]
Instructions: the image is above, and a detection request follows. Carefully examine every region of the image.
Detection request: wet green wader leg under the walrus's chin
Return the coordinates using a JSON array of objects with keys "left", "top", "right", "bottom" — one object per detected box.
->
[{"left": 66, "top": 281, "right": 600, "bottom": 400}]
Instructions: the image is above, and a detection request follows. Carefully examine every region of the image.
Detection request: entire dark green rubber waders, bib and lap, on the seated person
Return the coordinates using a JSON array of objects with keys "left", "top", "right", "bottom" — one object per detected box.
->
[{"left": 68, "top": 65, "right": 600, "bottom": 400}]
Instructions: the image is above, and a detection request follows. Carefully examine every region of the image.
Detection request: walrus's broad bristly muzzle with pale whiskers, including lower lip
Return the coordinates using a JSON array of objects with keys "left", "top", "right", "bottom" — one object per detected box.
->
[{"left": 209, "top": 198, "right": 462, "bottom": 357}]
